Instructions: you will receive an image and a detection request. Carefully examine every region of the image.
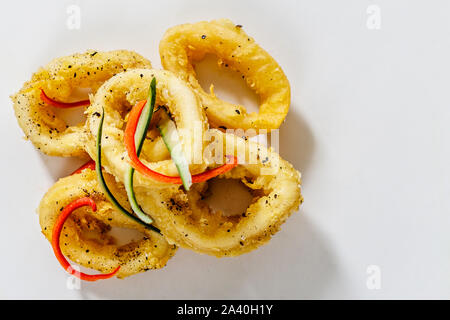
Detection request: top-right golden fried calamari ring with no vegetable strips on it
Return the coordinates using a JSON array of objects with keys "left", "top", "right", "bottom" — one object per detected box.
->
[{"left": 159, "top": 19, "right": 291, "bottom": 130}]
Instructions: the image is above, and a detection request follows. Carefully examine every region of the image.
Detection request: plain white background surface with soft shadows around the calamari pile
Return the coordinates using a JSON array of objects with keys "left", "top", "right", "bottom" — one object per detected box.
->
[{"left": 0, "top": 0, "right": 450, "bottom": 299}]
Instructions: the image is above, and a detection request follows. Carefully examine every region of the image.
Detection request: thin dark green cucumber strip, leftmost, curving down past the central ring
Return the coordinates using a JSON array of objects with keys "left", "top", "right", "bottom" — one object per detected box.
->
[{"left": 95, "top": 110, "right": 161, "bottom": 233}]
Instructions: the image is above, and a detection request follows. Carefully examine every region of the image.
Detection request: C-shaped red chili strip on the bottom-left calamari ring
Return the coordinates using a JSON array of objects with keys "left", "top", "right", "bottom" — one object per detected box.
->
[{"left": 52, "top": 197, "right": 120, "bottom": 281}]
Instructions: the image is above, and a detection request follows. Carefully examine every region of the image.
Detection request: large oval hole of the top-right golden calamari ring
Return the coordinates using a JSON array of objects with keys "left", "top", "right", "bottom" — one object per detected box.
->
[{"left": 192, "top": 54, "right": 260, "bottom": 113}]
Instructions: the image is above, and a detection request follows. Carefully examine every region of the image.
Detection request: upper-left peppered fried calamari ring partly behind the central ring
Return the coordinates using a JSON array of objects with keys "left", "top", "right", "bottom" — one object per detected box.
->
[{"left": 11, "top": 50, "right": 151, "bottom": 156}]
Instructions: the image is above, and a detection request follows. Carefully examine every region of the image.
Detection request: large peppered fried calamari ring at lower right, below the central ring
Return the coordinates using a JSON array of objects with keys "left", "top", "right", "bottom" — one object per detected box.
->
[{"left": 137, "top": 130, "right": 302, "bottom": 257}]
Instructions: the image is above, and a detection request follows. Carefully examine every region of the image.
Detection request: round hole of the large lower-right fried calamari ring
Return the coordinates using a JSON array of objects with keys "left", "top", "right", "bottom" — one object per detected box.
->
[{"left": 200, "top": 178, "right": 261, "bottom": 217}]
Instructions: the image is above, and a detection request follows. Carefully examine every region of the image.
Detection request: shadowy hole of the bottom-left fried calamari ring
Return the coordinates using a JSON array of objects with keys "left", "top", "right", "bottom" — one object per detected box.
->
[{"left": 68, "top": 208, "right": 145, "bottom": 247}]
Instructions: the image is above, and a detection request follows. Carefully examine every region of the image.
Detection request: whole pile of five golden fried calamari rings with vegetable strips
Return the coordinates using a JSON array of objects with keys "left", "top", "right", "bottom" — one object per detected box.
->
[{"left": 11, "top": 19, "right": 303, "bottom": 281}]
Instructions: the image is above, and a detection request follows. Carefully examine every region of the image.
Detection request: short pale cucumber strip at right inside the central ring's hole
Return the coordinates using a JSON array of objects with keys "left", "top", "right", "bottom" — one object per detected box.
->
[{"left": 158, "top": 110, "right": 192, "bottom": 191}]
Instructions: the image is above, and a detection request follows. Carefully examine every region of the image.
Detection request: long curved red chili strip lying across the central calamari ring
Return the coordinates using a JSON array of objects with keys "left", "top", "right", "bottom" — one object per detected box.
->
[{"left": 124, "top": 100, "right": 237, "bottom": 184}]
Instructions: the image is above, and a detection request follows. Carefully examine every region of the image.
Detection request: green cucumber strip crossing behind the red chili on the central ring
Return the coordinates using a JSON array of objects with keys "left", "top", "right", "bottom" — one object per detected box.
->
[{"left": 125, "top": 78, "right": 156, "bottom": 223}]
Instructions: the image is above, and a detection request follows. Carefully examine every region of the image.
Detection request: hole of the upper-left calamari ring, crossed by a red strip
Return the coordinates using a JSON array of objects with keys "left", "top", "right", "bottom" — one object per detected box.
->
[{"left": 50, "top": 88, "right": 92, "bottom": 127}]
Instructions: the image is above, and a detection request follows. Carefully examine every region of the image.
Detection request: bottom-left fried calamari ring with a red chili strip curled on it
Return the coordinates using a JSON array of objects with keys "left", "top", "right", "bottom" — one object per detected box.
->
[{"left": 38, "top": 170, "right": 176, "bottom": 278}]
